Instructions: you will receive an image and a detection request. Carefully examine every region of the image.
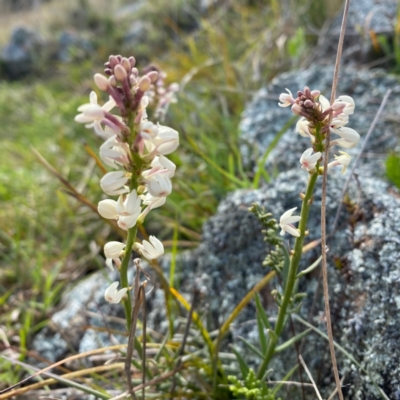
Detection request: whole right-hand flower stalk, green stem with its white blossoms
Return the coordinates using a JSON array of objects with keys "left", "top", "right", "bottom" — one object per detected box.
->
[{"left": 257, "top": 87, "right": 360, "bottom": 379}]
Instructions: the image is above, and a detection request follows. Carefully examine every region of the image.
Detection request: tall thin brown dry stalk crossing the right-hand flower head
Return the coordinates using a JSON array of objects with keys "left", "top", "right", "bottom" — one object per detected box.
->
[{"left": 321, "top": 0, "right": 350, "bottom": 400}]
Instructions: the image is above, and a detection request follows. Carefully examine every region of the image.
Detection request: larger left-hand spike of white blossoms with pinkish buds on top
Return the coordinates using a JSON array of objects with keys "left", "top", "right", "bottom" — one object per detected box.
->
[{"left": 75, "top": 56, "right": 179, "bottom": 302}]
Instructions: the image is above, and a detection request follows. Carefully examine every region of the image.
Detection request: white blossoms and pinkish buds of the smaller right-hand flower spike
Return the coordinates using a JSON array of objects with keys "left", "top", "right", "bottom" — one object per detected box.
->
[{"left": 278, "top": 86, "right": 360, "bottom": 237}]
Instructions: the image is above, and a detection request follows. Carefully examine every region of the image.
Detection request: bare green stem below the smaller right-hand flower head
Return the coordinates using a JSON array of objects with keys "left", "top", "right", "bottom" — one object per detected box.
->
[{"left": 257, "top": 169, "right": 318, "bottom": 379}]
